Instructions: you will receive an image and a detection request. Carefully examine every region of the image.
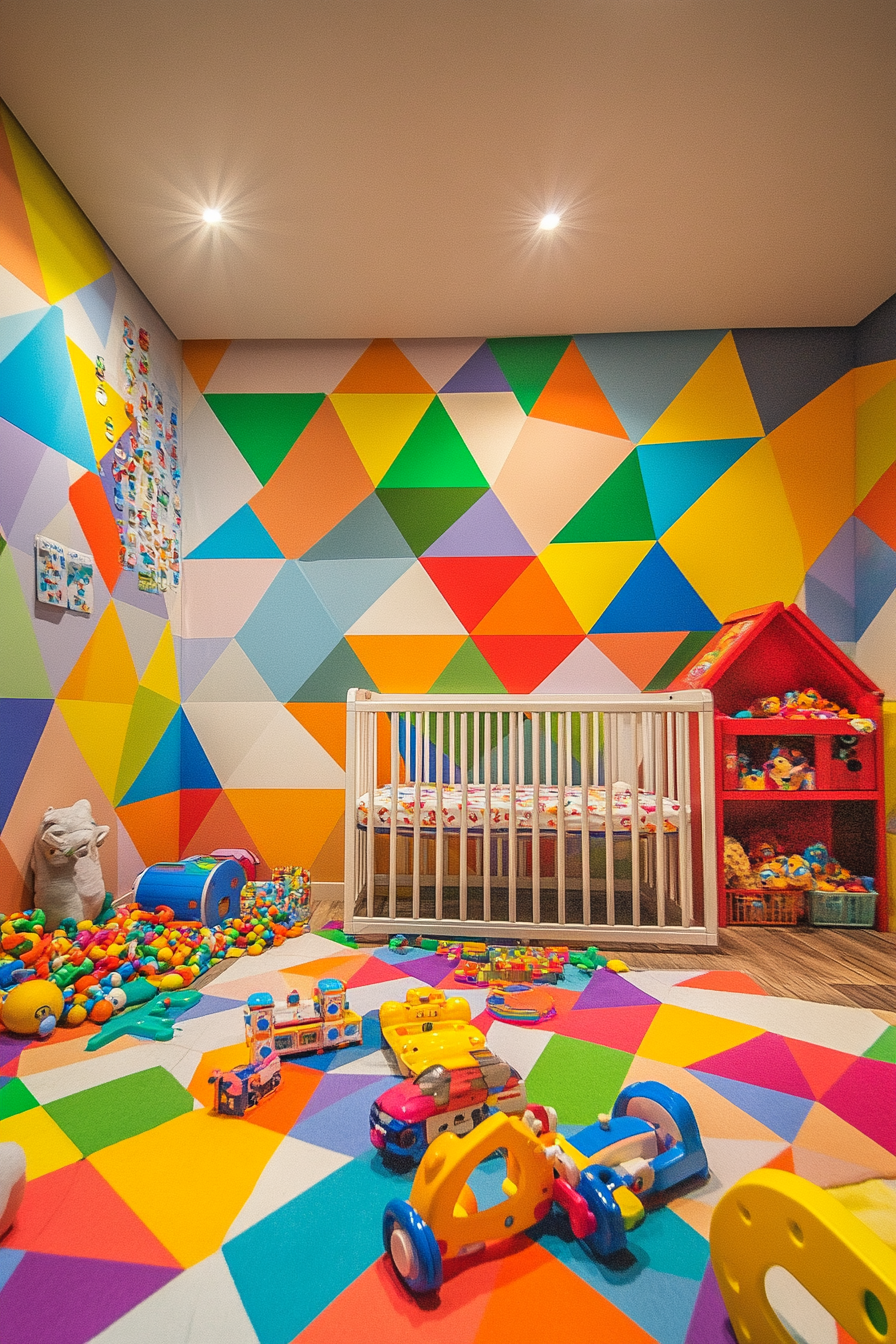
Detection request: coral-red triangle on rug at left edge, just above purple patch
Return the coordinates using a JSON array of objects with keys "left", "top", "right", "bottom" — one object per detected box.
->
[{"left": 3, "top": 1163, "right": 181, "bottom": 1269}]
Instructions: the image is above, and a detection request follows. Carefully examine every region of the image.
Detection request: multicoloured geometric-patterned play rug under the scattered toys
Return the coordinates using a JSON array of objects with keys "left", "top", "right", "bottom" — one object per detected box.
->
[{"left": 0, "top": 934, "right": 896, "bottom": 1344}]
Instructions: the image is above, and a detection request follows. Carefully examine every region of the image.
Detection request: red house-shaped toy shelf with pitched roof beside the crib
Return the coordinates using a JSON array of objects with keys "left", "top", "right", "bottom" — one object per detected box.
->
[{"left": 669, "top": 602, "right": 888, "bottom": 929}]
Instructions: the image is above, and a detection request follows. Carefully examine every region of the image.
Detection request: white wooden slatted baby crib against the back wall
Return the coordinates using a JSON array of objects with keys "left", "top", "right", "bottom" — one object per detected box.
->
[{"left": 345, "top": 689, "right": 717, "bottom": 945}]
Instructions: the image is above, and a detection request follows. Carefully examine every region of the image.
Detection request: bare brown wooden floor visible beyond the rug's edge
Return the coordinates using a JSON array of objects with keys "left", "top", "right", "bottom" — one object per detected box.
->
[{"left": 312, "top": 900, "right": 896, "bottom": 1023}]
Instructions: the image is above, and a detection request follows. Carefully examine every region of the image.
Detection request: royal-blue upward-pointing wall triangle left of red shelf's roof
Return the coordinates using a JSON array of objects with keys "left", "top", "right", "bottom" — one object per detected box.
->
[{"left": 588, "top": 543, "right": 719, "bottom": 634}]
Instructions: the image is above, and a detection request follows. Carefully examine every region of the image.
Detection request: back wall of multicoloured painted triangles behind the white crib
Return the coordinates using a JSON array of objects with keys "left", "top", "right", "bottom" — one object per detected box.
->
[{"left": 183, "top": 314, "right": 896, "bottom": 903}]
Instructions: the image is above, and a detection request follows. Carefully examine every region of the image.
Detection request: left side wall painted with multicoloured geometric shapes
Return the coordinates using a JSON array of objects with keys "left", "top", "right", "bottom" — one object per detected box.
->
[{"left": 0, "top": 105, "right": 181, "bottom": 913}]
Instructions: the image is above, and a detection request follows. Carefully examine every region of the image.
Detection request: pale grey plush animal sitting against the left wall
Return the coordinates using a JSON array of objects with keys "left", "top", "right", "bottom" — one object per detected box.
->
[{"left": 31, "top": 798, "right": 109, "bottom": 929}]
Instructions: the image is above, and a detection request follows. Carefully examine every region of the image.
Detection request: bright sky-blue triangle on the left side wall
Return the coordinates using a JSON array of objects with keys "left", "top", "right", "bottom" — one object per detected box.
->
[{"left": 0, "top": 308, "right": 97, "bottom": 476}]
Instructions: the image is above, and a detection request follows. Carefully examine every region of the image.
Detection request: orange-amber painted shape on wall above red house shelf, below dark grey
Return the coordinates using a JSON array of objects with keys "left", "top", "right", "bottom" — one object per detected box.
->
[{"left": 768, "top": 372, "right": 856, "bottom": 570}]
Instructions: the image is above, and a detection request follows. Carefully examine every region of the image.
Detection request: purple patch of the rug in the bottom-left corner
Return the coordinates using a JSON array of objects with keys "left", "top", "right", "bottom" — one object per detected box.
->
[{"left": 0, "top": 1251, "right": 183, "bottom": 1344}]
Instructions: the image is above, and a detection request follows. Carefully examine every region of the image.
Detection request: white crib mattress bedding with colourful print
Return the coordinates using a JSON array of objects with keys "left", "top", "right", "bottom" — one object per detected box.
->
[{"left": 357, "top": 782, "right": 681, "bottom": 835}]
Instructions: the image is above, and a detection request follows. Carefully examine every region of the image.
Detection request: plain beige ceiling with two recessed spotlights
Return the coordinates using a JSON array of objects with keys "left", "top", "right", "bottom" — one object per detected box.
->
[{"left": 0, "top": 0, "right": 896, "bottom": 337}]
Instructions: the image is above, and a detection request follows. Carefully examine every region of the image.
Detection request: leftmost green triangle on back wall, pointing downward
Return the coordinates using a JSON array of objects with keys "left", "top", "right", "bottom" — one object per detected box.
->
[{"left": 206, "top": 392, "right": 324, "bottom": 485}]
